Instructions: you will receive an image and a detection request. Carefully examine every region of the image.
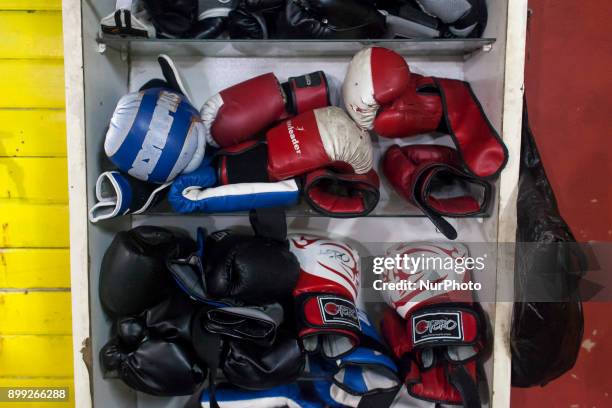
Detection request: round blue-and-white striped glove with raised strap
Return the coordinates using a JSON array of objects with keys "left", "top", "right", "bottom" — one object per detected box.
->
[{"left": 104, "top": 55, "right": 206, "bottom": 184}]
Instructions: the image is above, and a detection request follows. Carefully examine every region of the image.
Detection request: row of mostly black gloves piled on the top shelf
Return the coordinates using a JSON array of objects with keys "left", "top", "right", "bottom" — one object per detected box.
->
[{"left": 101, "top": 0, "right": 487, "bottom": 39}]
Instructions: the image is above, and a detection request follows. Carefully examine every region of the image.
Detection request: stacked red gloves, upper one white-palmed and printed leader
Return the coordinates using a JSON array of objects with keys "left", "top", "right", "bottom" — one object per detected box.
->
[{"left": 208, "top": 107, "right": 379, "bottom": 217}]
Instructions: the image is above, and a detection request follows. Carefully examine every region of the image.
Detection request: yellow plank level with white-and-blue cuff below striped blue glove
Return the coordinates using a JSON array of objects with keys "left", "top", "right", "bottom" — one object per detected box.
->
[{"left": 0, "top": 157, "right": 68, "bottom": 203}]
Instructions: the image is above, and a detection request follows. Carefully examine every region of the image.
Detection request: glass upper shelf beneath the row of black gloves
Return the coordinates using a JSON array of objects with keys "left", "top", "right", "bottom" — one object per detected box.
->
[{"left": 98, "top": 36, "right": 495, "bottom": 57}]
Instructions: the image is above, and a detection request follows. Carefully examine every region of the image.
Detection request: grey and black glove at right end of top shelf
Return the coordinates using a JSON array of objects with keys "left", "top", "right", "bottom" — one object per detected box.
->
[{"left": 415, "top": 0, "right": 487, "bottom": 38}]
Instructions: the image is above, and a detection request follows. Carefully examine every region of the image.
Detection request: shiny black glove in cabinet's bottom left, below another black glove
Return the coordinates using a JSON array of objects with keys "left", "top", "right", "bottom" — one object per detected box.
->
[{"left": 100, "top": 294, "right": 205, "bottom": 396}]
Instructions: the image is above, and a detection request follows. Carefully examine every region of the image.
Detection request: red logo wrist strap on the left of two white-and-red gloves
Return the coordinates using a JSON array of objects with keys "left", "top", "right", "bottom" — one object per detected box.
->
[{"left": 296, "top": 293, "right": 361, "bottom": 333}]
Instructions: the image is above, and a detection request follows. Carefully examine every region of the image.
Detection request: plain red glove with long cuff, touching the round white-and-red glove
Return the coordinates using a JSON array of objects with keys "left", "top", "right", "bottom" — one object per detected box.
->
[{"left": 374, "top": 75, "right": 508, "bottom": 179}]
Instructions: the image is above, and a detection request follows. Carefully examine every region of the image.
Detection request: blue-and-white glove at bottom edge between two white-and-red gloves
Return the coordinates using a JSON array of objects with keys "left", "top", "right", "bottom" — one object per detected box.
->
[{"left": 309, "top": 310, "right": 401, "bottom": 407}]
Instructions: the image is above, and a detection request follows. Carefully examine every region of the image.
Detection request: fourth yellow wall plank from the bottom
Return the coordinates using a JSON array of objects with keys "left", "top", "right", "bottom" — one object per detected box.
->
[{"left": 0, "top": 248, "right": 70, "bottom": 288}]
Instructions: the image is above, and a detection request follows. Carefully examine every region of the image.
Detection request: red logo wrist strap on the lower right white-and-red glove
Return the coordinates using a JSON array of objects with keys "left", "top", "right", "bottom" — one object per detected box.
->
[{"left": 407, "top": 306, "right": 481, "bottom": 348}]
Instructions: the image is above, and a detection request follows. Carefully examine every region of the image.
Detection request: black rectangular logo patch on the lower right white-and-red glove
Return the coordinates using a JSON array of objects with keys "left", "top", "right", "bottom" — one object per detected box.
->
[{"left": 412, "top": 312, "right": 463, "bottom": 344}]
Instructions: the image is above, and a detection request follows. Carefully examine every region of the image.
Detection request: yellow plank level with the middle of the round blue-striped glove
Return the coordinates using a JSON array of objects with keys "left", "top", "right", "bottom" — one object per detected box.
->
[{"left": 0, "top": 109, "right": 66, "bottom": 157}]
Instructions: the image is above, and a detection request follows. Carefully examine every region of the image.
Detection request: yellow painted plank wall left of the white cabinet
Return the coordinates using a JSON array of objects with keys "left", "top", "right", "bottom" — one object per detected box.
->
[{"left": 0, "top": 0, "right": 74, "bottom": 408}]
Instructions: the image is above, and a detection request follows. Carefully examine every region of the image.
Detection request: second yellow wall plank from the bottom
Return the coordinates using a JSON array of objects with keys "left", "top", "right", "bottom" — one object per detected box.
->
[{"left": 0, "top": 336, "right": 72, "bottom": 377}]
